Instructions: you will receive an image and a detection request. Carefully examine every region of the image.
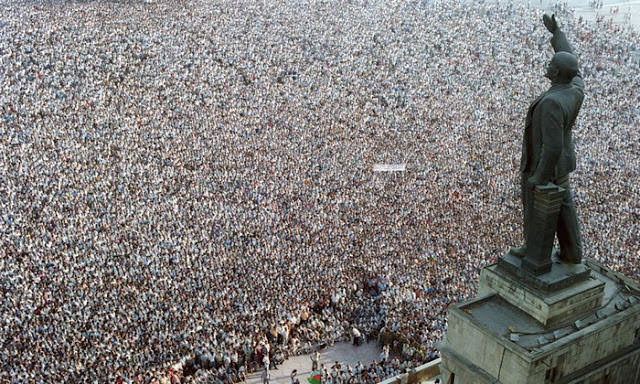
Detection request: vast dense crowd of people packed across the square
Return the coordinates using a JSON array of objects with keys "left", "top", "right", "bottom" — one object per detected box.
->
[{"left": 0, "top": 0, "right": 640, "bottom": 383}]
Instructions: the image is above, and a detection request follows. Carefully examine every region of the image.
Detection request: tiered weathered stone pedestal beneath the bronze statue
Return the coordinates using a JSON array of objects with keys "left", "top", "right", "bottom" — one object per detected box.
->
[{"left": 439, "top": 260, "right": 640, "bottom": 384}]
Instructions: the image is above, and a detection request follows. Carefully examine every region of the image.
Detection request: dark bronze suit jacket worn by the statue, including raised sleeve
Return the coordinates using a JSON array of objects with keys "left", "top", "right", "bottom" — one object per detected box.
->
[{"left": 520, "top": 30, "right": 584, "bottom": 184}]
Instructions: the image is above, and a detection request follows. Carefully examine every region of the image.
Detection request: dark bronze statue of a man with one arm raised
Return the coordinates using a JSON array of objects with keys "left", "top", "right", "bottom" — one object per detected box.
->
[{"left": 510, "top": 15, "right": 584, "bottom": 275}]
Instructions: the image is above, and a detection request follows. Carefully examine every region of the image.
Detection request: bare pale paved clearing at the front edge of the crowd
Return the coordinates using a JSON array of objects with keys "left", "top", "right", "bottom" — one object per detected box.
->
[{"left": 247, "top": 342, "right": 382, "bottom": 384}]
